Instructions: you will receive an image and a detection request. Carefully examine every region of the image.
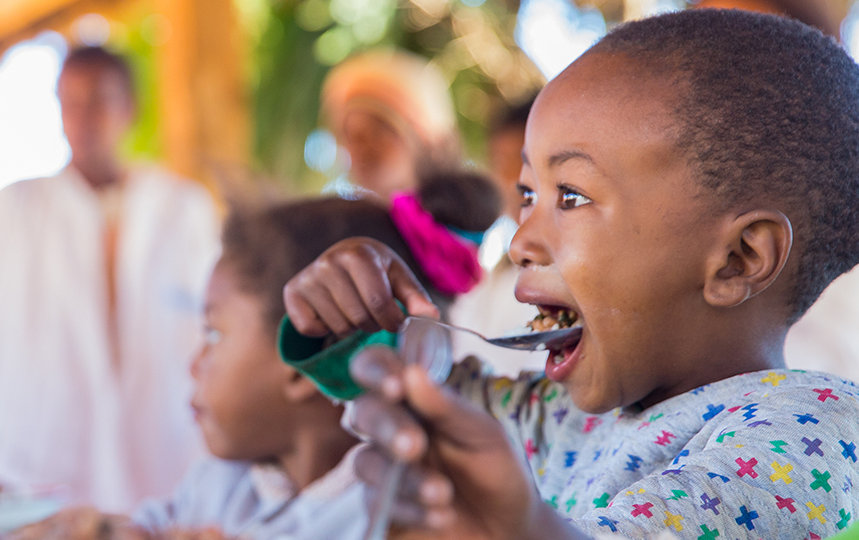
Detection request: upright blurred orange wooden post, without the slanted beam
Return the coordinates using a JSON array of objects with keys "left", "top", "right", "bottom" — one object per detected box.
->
[{"left": 154, "top": 0, "right": 250, "bottom": 193}]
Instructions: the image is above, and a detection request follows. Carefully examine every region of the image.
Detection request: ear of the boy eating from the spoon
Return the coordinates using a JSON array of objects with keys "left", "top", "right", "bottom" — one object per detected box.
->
[{"left": 704, "top": 210, "right": 793, "bottom": 307}]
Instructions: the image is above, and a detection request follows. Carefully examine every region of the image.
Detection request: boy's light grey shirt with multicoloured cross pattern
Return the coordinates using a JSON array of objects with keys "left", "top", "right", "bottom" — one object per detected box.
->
[{"left": 453, "top": 363, "right": 859, "bottom": 539}]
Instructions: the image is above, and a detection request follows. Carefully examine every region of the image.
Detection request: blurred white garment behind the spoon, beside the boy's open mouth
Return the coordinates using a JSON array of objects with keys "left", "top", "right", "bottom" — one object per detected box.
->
[{"left": 449, "top": 218, "right": 548, "bottom": 378}]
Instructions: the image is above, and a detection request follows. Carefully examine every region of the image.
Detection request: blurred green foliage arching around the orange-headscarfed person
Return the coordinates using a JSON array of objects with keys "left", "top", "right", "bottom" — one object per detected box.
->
[{"left": 248, "top": 0, "right": 542, "bottom": 192}]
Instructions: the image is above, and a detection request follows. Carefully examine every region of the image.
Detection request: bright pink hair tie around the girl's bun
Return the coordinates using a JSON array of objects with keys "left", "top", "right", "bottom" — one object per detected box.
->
[{"left": 391, "top": 193, "right": 481, "bottom": 295}]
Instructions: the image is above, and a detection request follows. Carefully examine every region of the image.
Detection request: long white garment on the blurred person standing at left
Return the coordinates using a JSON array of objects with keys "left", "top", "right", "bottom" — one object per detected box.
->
[{"left": 0, "top": 168, "right": 218, "bottom": 512}]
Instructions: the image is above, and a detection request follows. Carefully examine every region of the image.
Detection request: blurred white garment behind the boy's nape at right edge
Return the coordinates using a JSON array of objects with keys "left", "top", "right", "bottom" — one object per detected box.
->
[{"left": 785, "top": 266, "right": 859, "bottom": 382}]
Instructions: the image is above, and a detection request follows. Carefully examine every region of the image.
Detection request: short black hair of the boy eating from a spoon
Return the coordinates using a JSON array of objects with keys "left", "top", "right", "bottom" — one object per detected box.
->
[{"left": 591, "top": 9, "right": 859, "bottom": 322}]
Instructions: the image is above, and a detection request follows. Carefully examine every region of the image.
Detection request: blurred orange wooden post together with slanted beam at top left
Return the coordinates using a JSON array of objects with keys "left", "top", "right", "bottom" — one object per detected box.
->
[{"left": 0, "top": 0, "right": 250, "bottom": 194}]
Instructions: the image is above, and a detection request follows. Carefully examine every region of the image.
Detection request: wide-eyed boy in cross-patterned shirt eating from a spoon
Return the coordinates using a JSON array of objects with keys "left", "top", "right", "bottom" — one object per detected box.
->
[{"left": 285, "top": 10, "right": 859, "bottom": 538}]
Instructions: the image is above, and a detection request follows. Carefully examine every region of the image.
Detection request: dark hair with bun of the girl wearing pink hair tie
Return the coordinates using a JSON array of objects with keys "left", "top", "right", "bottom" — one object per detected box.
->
[{"left": 222, "top": 172, "right": 500, "bottom": 332}]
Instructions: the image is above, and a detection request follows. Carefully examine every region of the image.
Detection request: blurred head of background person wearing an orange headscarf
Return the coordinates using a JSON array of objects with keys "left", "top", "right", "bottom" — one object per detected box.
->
[{"left": 321, "top": 49, "right": 462, "bottom": 201}]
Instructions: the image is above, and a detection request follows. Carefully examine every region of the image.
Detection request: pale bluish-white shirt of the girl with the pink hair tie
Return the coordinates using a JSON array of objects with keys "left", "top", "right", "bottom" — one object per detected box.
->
[{"left": 133, "top": 449, "right": 368, "bottom": 540}]
